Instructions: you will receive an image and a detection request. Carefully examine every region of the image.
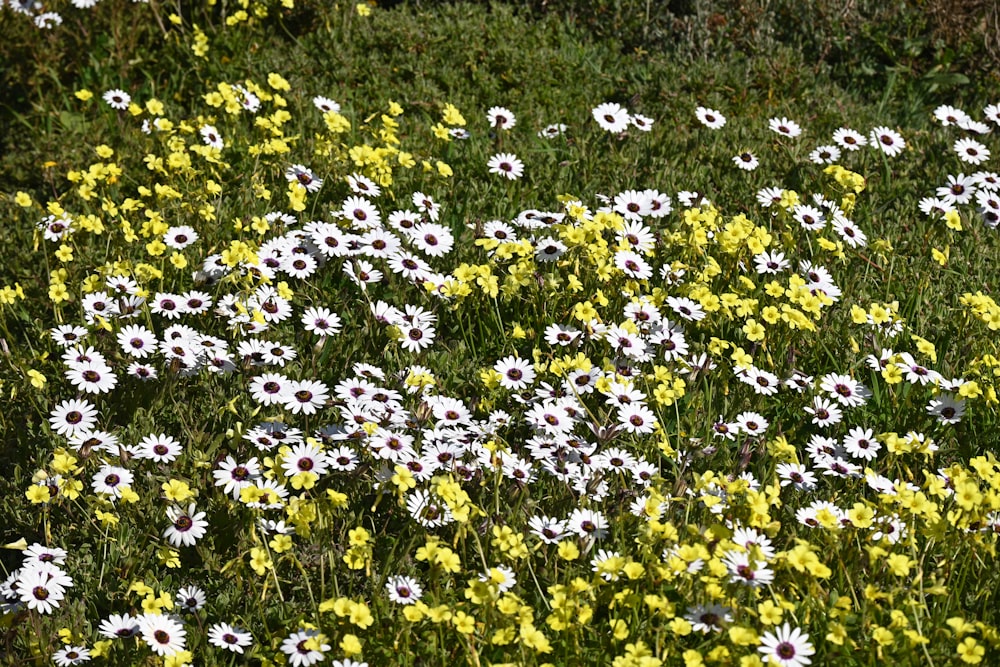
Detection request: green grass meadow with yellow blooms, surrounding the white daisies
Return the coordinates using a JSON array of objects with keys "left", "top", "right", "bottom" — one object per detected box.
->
[{"left": 0, "top": 0, "right": 1000, "bottom": 665}]
